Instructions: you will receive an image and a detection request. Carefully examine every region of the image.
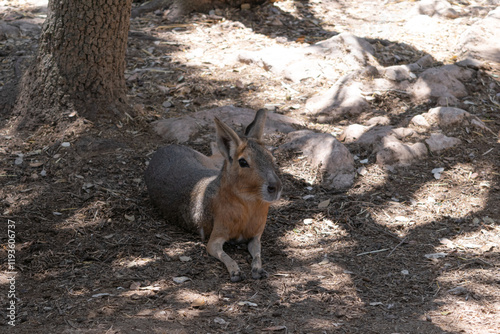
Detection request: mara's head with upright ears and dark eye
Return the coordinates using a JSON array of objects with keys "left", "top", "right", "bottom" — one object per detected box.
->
[{"left": 215, "top": 109, "right": 282, "bottom": 202}]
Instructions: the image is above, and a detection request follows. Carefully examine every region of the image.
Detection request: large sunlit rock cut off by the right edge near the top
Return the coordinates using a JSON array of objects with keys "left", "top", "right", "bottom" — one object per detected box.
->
[{"left": 456, "top": 7, "right": 500, "bottom": 63}]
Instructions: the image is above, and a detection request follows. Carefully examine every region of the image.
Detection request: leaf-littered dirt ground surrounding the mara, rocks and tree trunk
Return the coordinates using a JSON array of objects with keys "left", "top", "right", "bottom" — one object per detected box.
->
[{"left": 0, "top": 0, "right": 500, "bottom": 333}]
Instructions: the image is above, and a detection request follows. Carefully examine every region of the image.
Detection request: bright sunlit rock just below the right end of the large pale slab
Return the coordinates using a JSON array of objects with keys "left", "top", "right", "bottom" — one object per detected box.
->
[{"left": 305, "top": 75, "right": 370, "bottom": 122}]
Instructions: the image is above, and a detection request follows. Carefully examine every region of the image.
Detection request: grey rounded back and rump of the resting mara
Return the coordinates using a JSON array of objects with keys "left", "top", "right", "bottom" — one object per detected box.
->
[{"left": 144, "top": 145, "right": 219, "bottom": 232}]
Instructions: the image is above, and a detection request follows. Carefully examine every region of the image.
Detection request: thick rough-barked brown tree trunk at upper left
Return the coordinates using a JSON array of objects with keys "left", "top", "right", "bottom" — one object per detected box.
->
[{"left": 15, "top": 0, "right": 132, "bottom": 128}]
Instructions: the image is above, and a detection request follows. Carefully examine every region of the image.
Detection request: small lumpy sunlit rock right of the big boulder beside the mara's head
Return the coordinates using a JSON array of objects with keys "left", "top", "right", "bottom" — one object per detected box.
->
[{"left": 377, "top": 136, "right": 427, "bottom": 166}]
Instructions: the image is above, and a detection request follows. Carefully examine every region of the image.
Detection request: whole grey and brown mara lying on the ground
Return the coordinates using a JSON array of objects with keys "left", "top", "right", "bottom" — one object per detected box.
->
[{"left": 145, "top": 110, "right": 281, "bottom": 281}]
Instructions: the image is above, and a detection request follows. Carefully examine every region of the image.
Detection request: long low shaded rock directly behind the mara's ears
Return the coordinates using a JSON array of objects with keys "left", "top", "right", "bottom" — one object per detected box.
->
[{"left": 153, "top": 106, "right": 298, "bottom": 143}]
